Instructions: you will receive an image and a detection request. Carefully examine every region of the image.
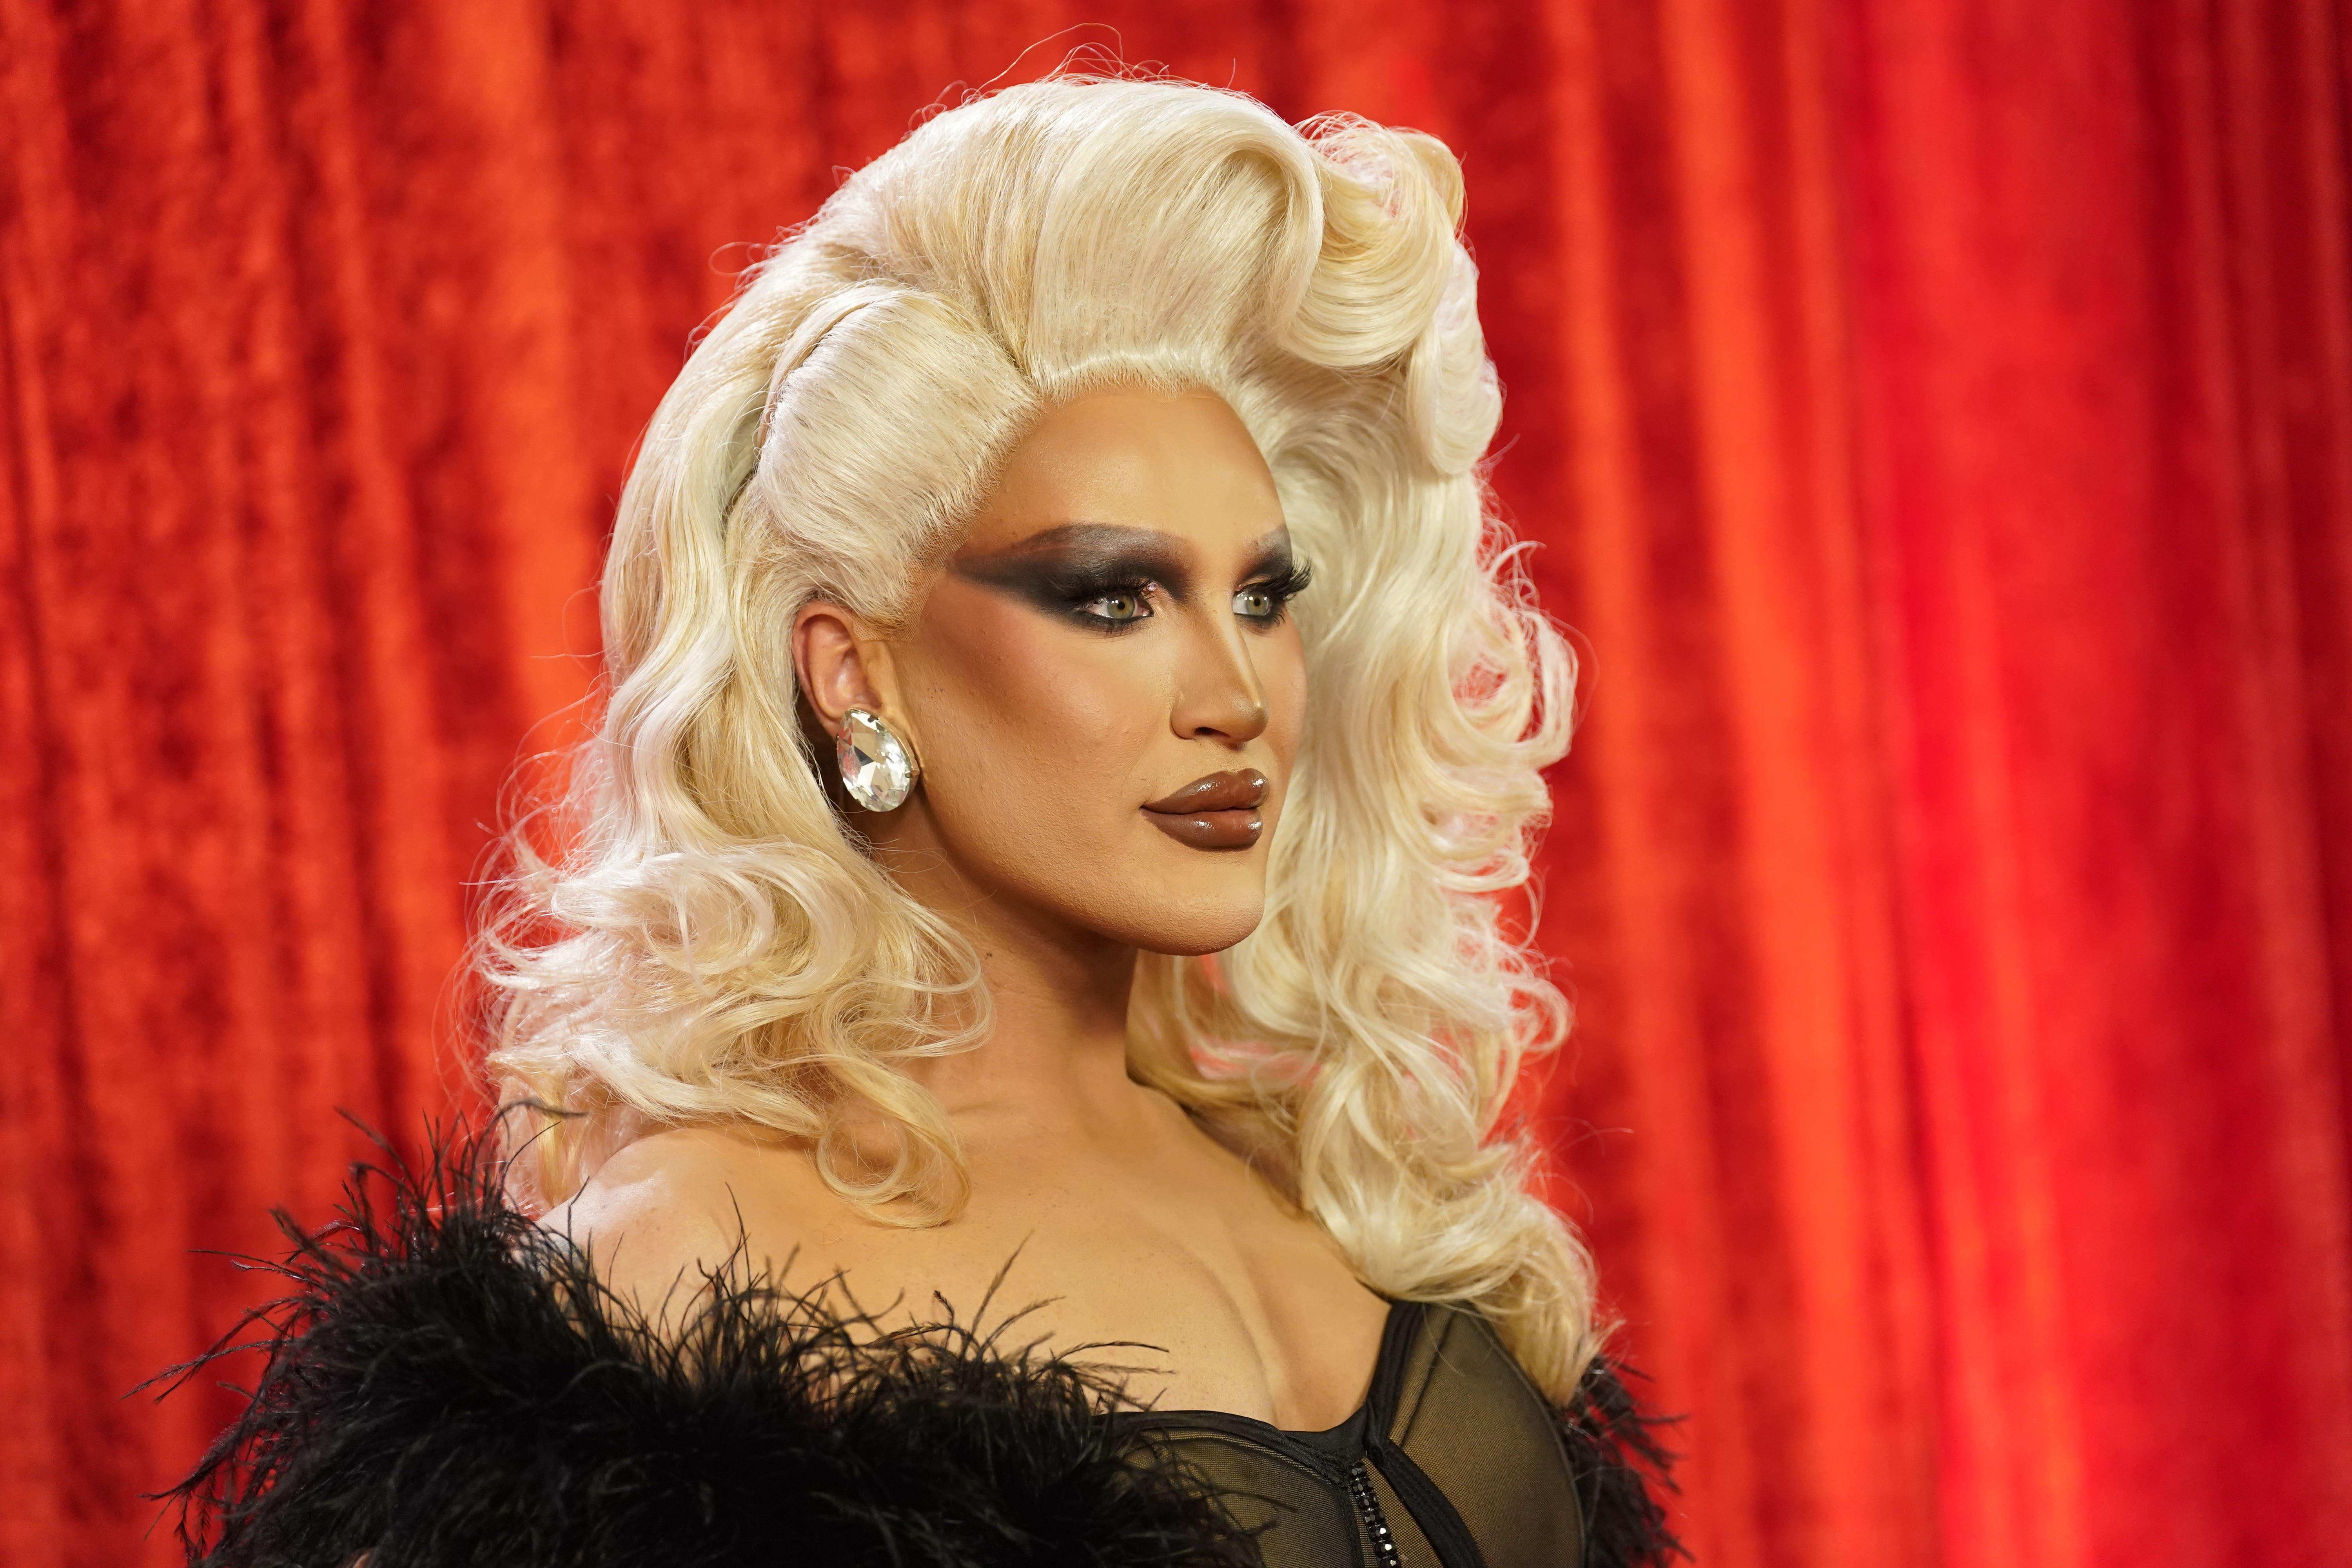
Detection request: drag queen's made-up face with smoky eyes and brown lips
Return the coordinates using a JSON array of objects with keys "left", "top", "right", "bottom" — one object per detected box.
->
[{"left": 802, "top": 392, "right": 1305, "bottom": 955}]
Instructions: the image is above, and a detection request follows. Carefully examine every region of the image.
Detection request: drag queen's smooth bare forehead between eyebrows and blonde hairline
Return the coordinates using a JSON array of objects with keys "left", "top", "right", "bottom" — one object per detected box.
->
[{"left": 962, "top": 390, "right": 1282, "bottom": 550}]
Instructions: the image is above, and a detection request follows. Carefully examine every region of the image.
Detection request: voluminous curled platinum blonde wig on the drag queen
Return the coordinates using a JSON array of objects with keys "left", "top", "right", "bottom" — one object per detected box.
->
[{"left": 482, "top": 78, "right": 1592, "bottom": 1396}]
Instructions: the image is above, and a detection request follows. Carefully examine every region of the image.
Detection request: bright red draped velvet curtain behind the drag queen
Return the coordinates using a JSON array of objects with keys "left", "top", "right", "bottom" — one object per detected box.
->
[{"left": 0, "top": 0, "right": 2352, "bottom": 1568}]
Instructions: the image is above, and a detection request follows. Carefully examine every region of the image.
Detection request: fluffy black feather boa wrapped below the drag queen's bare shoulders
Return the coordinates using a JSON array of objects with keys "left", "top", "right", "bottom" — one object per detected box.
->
[{"left": 169, "top": 1133, "right": 1672, "bottom": 1568}]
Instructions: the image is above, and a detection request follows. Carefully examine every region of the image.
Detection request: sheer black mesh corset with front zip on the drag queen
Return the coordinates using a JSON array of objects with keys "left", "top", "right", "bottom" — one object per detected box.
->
[{"left": 1112, "top": 1302, "right": 1583, "bottom": 1568}]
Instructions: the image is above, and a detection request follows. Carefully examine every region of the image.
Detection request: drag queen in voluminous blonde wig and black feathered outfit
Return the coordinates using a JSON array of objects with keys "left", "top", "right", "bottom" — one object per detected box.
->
[{"left": 186, "top": 78, "right": 1672, "bottom": 1568}]
